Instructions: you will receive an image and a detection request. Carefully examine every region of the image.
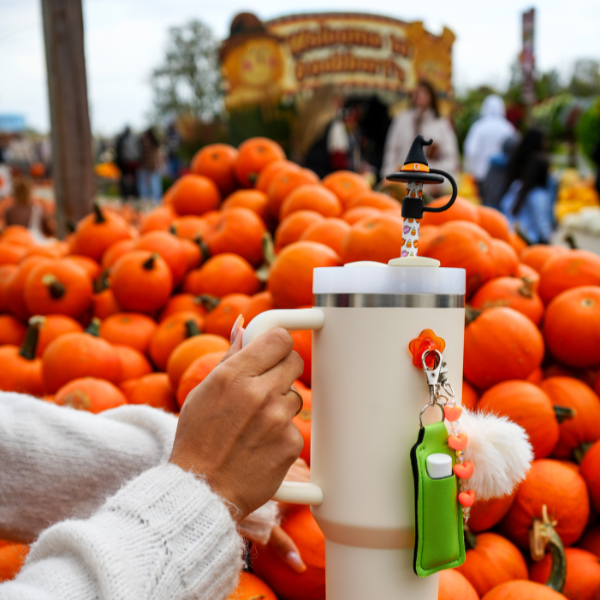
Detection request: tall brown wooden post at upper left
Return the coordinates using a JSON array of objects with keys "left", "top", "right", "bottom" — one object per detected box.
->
[{"left": 41, "top": 0, "right": 95, "bottom": 237}]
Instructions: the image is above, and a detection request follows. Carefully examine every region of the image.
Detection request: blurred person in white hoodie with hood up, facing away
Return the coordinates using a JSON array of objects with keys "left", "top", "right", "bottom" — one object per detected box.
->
[{"left": 464, "top": 94, "right": 515, "bottom": 195}]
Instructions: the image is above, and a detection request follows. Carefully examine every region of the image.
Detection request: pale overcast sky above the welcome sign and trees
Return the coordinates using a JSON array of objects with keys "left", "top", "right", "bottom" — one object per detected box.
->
[{"left": 0, "top": 0, "right": 600, "bottom": 134}]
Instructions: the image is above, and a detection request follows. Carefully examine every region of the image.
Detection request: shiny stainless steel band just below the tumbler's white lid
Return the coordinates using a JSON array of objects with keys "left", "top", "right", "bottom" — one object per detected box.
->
[{"left": 313, "top": 294, "right": 465, "bottom": 308}]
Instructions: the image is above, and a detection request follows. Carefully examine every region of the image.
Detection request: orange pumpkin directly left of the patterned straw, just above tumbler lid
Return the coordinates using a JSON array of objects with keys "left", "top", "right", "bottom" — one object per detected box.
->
[{"left": 340, "top": 214, "right": 402, "bottom": 264}]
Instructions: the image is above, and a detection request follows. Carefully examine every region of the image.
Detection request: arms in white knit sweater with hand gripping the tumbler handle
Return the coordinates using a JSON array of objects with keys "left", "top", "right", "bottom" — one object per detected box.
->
[{"left": 0, "top": 329, "right": 303, "bottom": 600}]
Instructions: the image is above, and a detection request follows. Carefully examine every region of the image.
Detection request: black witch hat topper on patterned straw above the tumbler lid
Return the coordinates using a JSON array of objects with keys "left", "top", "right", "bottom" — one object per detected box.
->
[{"left": 386, "top": 135, "right": 458, "bottom": 258}]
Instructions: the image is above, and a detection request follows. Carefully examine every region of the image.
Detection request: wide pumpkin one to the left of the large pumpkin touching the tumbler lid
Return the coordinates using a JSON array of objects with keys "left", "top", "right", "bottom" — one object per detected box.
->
[{"left": 183, "top": 254, "right": 260, "bottom": 298}]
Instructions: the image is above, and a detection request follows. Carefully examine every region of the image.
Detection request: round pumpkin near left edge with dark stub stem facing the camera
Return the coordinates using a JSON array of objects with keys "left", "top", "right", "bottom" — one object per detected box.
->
[{"left": 23, "top": 258, "right": 93, "bottom": 318}]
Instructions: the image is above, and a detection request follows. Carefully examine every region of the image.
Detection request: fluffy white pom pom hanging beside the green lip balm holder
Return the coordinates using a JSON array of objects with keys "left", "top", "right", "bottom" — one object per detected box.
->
[{"left": 446, "top": 409, "right": 533, "bottom": 500}]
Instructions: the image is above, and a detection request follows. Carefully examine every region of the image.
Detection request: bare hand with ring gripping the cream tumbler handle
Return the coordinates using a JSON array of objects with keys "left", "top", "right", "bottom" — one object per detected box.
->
[{"left": 170, "top": 328, "right": 304, "bottom": 521}]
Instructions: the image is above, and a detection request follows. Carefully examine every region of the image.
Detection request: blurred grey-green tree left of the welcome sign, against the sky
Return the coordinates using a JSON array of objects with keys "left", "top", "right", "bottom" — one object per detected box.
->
[{"left": 151, "top": 20, "right": 223, "bottom": 121}]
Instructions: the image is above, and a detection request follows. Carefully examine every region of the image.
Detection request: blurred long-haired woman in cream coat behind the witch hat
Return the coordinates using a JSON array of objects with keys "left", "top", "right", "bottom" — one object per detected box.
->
[{"left": 381, "top": 81, "right": 459, "bottom": 189}]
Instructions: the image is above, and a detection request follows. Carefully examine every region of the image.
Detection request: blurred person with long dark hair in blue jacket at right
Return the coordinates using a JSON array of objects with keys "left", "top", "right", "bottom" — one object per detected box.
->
[{"left": 500, "top": 153, "right": 553, "bottom": 244}]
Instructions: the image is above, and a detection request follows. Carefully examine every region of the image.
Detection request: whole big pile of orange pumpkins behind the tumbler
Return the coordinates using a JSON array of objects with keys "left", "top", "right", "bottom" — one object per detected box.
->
[{"left": 0, "top": 138, "right": 600, "bottom": 600}]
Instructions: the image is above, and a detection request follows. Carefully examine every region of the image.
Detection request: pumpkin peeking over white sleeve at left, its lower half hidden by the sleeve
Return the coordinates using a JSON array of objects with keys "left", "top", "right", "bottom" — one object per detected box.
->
[{"left": 54, "top": 377, "right": 127, "bottom": 414}]
